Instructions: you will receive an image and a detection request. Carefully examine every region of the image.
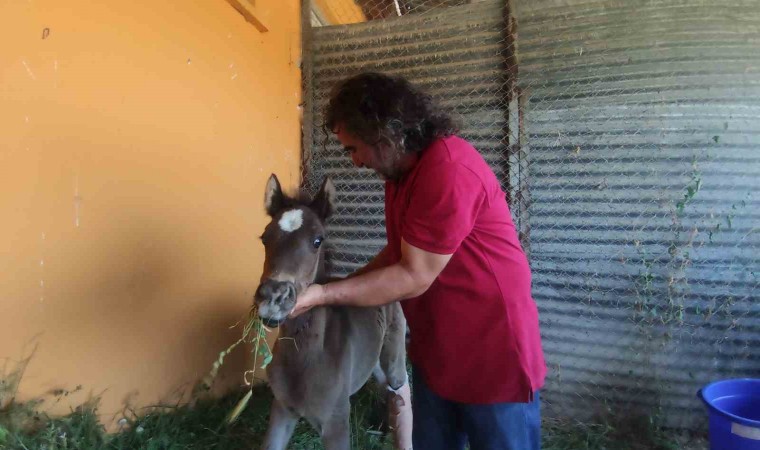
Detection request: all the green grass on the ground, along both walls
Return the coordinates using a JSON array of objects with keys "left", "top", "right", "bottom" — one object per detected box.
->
[{"left": 0, "top": 383, "right": 706, "bottom": 450}]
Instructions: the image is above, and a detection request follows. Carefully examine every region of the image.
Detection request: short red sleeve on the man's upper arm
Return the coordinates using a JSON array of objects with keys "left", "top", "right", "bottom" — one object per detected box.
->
[{"left": 402, "top": 162, "right": 485, "bottom": 255}]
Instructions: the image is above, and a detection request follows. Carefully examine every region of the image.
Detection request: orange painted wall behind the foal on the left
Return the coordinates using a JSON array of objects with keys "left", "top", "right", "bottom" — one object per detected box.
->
[{"left": 0, "top": 0, "right": 300, "bottom": 422}]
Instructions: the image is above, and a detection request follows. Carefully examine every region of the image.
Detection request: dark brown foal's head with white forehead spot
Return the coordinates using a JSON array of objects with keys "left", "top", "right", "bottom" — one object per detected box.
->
[{"left": 255, "top": 175, "right": 335, "bottom": 327}]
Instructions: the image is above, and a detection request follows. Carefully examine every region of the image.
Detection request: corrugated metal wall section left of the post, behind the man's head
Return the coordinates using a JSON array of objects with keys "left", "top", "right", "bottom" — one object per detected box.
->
[{"left": 305, "top": 1, "right": 507, "bottom": 274}]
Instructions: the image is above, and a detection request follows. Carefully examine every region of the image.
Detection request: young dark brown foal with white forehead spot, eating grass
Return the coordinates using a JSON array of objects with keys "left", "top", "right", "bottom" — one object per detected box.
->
[{"left": 255, "top": 175, "right": 412, "bottom": 450}]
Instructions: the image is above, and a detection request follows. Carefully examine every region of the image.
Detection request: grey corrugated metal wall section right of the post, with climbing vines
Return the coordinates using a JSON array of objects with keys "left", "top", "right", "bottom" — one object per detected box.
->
[{"left": 517, "top": 0, "right": 760, "bottom": 427}]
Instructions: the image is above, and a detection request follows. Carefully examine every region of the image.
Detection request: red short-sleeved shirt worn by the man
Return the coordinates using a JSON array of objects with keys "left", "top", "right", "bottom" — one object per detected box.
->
[{"left": 385, "top": 136, "right": 546, "bottom": 404}]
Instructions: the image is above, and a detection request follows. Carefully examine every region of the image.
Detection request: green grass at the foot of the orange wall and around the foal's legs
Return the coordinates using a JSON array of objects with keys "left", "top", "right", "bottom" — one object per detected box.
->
[{"left": 0, "top": 386, "right": 391, "bottom": 450}]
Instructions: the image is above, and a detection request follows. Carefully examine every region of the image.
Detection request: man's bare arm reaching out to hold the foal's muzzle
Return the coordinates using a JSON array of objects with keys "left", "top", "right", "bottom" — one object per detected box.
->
[{"left": 291, "top": 240, "right": 451, "bottom": 316}]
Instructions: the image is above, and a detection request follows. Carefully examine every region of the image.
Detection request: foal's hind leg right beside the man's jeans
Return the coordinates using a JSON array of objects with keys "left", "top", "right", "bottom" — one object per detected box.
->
[{"left": 380, "top": 304, "right": 412, "bottom": 450}]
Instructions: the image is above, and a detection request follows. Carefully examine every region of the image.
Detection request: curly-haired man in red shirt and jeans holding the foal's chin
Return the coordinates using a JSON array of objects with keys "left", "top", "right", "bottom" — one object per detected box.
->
[{"left": 292, "top": 73, "right": 546, "bottom": 450}]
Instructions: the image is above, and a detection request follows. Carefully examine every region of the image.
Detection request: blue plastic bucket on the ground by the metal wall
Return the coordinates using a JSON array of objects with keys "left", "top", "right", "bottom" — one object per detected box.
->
[{"left": 698, "top": 378, "right": 760, "bottom": 450}]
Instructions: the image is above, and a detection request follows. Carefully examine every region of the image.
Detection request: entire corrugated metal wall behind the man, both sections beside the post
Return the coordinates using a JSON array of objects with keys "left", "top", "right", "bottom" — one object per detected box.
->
[{"left": 304, "top": 0, "right": 760, "bottom": 428}]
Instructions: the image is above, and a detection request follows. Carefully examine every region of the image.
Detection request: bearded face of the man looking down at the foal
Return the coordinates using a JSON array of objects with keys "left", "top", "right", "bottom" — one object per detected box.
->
[{"left": 335, "top": 126, "right": 402, "bottom": 180}]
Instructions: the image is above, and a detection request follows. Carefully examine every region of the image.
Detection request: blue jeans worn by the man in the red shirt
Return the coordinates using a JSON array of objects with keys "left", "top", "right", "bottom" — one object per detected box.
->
[{"left": 412, "top": 375, "right": 541, "bottom": 450}]
